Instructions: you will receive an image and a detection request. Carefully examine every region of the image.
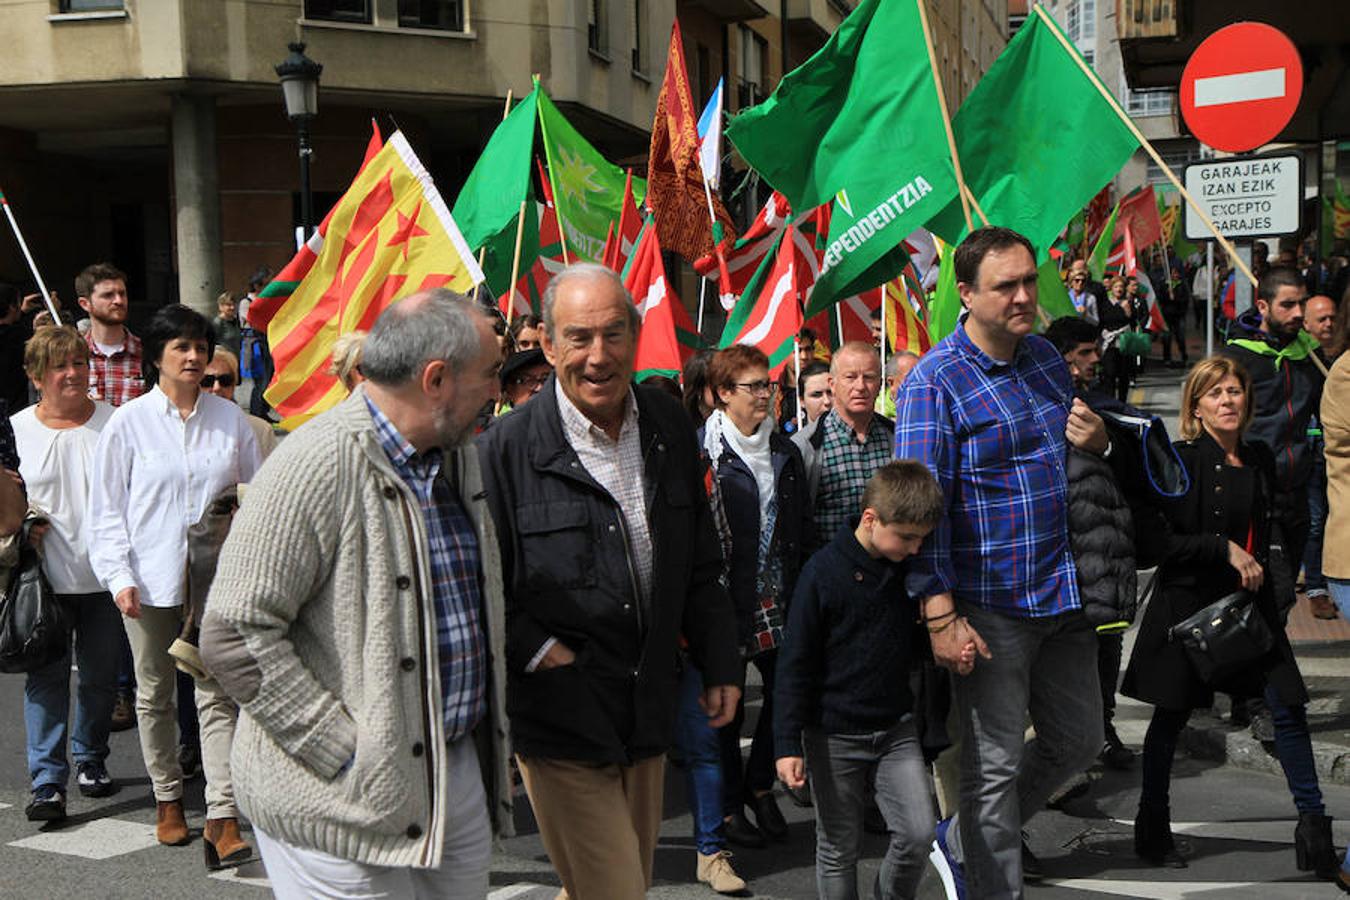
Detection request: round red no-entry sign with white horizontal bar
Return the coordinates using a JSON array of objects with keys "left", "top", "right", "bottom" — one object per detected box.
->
[{"left": 1179, "top": 22, "right": 1303, "bottom": 152}]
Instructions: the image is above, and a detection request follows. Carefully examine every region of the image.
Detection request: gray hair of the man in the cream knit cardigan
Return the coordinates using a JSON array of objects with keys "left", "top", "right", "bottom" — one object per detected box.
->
[{"left": 360, "top": 287, "right": 483, "bottom": 387}]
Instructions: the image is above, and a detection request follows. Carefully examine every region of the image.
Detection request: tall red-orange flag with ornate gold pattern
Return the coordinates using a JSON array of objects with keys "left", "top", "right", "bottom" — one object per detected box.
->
[{"left": 647, "top": 19, "right": 734, "bottom": 262}]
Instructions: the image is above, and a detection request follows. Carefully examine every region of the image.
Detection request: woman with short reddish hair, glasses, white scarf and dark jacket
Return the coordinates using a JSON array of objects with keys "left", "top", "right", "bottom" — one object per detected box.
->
[{"left": 699, "top": 345, "right": 813, "bottom": 841}]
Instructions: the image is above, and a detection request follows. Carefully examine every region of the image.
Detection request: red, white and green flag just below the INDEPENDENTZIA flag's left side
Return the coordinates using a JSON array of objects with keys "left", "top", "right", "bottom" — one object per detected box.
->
[{"left": 718, "top": 225, "right": 802, "bottom": 379}]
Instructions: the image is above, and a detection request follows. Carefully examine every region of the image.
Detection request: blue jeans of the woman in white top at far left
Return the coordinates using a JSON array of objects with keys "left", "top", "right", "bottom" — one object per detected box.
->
[{"left": 23, "top": 592, "right": 122, "bottom": 789}]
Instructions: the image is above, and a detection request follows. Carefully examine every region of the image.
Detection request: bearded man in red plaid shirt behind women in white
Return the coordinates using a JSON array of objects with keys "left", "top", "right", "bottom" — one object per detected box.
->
[{"left": 76, "top": 263, "right": 146, "bottom": 406}]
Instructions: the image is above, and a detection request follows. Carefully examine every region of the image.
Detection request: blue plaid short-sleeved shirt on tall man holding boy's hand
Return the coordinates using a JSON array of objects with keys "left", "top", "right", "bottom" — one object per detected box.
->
[{"left": 895, "top": 316, "right": 1081, "bottom": 617}]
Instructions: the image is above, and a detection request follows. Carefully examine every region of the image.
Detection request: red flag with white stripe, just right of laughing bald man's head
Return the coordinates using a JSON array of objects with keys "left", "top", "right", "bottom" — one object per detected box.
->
[{"left": 624, "top": 223, "right": 694, "bottom": 382}]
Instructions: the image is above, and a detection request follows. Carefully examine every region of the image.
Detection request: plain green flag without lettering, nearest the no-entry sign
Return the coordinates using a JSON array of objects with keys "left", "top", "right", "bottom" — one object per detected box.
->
[{"left": 929, "top": 15, "right": 1139, "bottom": 262}]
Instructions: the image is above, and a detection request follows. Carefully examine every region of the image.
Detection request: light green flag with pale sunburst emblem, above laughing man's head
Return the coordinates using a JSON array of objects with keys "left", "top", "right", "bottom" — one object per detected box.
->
[{"left": 536, "top": 88, "right": 647, "bottom": 262}]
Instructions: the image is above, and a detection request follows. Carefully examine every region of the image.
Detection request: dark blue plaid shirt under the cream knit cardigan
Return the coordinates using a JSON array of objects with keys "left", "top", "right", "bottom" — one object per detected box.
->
[{"left": 366, "top": 397, "right": 487, "bottom": 742}]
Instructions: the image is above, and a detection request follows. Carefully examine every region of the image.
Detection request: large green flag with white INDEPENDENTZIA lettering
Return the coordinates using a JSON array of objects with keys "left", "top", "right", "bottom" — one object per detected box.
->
[{"left": 726, "top": 0, "right": 957, "bottom": 317}]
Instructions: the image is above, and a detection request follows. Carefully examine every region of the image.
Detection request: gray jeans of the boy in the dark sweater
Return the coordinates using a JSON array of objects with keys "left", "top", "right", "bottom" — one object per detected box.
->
[{"left": 802, "top": 718, "right": 934, "bottom": 900}]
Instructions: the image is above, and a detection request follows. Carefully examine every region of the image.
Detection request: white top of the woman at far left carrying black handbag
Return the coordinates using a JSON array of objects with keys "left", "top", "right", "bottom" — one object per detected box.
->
[{"left": 9, "top": 401, "right": 112, "bottom": 594}]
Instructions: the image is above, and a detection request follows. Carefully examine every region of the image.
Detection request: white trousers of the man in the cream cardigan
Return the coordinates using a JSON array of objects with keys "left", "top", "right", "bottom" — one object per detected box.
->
[{"left": 254, "top": 737, "right": 491, "bottom": 900}]
